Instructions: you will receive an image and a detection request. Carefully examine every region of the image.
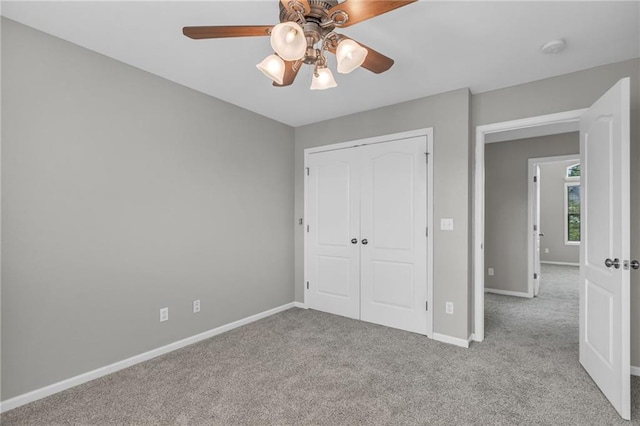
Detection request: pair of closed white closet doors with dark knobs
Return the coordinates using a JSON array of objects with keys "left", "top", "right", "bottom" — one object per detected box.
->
[{"left": 306, "top": 136, "right": 428, "bottom": 334}]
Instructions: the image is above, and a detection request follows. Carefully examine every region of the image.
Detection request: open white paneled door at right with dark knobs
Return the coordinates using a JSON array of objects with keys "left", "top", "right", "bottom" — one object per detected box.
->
[{"left": 580, "top": 78, "right": 631, "bottom": 420}]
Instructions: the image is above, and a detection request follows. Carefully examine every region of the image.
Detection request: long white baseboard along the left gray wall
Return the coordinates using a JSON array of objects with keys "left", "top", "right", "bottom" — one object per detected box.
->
[{"left": 0, "top": 302, "right": 296, "bottom": 413}]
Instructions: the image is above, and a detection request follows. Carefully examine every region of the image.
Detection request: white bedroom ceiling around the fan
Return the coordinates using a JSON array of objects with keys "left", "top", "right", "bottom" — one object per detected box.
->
[{"left": 2, "top": 0, "right": 640, "bottom": 126}]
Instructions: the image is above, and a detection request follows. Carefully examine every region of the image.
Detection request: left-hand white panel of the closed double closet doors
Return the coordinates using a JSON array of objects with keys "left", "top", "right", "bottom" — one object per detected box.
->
[{"left": 307, "top": 150, "right": 360, "bottom": 319}]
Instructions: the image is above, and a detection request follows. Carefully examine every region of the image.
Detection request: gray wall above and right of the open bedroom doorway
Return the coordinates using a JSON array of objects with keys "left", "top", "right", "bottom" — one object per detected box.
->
[{"left": 470, "top": 59, "right": 640, "bottom": 366}]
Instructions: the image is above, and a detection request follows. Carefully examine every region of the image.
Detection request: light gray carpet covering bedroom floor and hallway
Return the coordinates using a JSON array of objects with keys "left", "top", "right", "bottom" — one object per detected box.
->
[{"left": 1, "top": 265, "right": 640, "bottom": 425}]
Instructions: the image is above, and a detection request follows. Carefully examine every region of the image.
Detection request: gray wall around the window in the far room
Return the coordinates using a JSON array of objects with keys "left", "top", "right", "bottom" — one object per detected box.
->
[{"left": 540, "top": 161, "right": 580, "bottom": 264}]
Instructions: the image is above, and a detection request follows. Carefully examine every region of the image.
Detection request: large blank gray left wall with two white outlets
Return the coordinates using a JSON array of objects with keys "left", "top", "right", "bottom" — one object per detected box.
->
[{"left": 2, "top": 20, "right": 294, "bottom": 399}]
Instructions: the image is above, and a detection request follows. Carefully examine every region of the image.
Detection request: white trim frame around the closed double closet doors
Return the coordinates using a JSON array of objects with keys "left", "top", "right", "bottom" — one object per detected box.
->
[{"left": 302, "top": 127, "right": 434, "bottom": 338}]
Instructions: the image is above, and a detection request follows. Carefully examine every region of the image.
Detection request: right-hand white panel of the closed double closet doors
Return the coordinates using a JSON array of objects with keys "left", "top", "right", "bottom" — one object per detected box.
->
[{"left": 360, "top": 137, "right": 427, "bottom": 334}]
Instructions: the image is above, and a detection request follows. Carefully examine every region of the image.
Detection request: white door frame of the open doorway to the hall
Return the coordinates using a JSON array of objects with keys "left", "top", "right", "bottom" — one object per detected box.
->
[{"left": 473, "top": 109, "right": 586, "bottom": 342}]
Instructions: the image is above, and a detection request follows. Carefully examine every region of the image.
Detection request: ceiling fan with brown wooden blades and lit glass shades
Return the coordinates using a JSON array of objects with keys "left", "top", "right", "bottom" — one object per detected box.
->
[{"left": 182, "top": 0, "right": 417, "bottom": 90}]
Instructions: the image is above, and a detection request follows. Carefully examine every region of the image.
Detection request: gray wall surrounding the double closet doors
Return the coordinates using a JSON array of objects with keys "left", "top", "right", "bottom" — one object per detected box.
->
[{"left": 295, "top": 89, "right": 469, "bottom": 339}]
